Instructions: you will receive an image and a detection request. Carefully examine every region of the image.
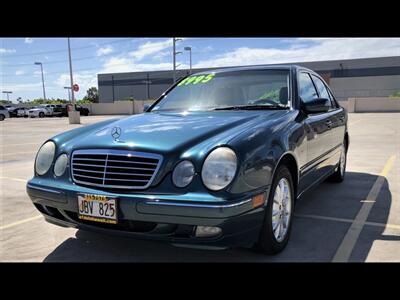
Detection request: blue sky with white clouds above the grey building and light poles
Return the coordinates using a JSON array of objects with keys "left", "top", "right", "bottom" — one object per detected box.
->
[{"left": 0, "top": 37, "right": 400, "bottom": 102}]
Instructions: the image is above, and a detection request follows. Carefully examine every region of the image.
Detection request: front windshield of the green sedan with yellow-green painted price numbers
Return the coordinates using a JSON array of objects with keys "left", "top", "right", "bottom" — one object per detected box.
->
[{"left": 152, "top": 69, "right": 289, "bottom": 111}]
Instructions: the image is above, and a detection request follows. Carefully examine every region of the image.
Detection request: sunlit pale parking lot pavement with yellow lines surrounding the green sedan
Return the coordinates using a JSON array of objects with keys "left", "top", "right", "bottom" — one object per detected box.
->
[{"left": 0, "top": 113, "right": 400, "bottom": 262}]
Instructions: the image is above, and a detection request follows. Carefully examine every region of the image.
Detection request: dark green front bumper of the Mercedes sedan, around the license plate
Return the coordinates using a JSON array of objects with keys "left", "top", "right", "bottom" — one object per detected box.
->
[{"left": 27, "top": 177, "right": 268, "bottom": 248}]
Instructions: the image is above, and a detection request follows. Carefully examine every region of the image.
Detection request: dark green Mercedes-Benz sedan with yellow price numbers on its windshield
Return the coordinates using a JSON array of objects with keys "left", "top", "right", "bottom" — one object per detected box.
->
[{"left": 27, "top": 65, "right": 349, "bottom": 254}]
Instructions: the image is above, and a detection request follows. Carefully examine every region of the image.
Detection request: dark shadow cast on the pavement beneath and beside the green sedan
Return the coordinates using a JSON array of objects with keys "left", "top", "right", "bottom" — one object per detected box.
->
[{"left": 44, "top": 172, "right": 394, "bottom": 262}]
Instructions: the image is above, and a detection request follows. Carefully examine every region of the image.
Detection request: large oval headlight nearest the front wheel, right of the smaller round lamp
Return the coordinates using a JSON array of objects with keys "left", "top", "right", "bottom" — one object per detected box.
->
[{"left": 201, "top": 147, "right": 237, "bottom": 191}]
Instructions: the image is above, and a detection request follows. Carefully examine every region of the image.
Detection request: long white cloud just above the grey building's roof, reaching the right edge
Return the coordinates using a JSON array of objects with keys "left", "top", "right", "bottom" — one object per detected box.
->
[{"left": 194, "top": 38, "right": 400, "bottom": 68}]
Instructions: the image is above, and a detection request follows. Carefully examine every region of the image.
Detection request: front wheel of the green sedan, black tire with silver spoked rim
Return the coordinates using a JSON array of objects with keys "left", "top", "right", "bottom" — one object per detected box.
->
[{"left": 254, "top": 165, "right": 294, "bottom": 254}]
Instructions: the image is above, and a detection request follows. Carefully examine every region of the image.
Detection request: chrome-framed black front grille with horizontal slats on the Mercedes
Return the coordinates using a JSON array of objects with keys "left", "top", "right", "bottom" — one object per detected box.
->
[{"left": 71, "top": 149, "right": 162, "bottom": 189}]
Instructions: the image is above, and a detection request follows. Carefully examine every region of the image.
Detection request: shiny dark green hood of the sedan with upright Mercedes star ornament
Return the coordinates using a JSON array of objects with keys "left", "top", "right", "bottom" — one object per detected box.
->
[{"left": 57, "top": 110, "right": 287, "bottom": 153}]
